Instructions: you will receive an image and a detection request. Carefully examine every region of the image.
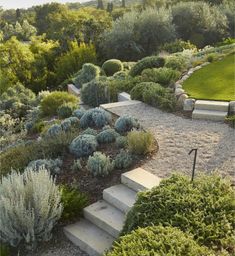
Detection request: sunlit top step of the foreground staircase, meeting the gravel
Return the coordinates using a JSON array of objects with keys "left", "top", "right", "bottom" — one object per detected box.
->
[{"left": 121, "top": 168, "right": 161, "bottom": 192}]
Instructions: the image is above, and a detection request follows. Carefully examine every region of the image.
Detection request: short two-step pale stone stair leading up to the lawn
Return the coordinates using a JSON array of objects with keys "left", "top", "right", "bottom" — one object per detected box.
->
[{"left": 192, "top": 100, "right": 229, "bottom": 121}]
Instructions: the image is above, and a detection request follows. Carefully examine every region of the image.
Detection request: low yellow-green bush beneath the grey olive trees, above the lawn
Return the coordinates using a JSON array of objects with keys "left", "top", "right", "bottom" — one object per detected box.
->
[{"left": 160, "top": 39, "right": 197, "bottom": 53}]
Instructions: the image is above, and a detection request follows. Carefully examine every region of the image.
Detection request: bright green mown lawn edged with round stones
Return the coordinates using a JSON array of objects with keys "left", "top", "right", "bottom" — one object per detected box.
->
[{"left": 183, "top": 53, "right": 235, "bottom": 101}]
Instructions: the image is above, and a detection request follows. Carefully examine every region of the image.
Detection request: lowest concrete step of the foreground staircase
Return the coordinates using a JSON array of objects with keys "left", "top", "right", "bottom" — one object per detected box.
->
[{"left": 64, "top": 219, "right": 114, "bottom": 256}]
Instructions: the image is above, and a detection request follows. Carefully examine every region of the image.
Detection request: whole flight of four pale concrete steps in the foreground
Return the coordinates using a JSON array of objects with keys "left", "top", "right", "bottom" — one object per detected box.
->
[{"left": 64, "top": 168, "right": 161, "bottom": 256}]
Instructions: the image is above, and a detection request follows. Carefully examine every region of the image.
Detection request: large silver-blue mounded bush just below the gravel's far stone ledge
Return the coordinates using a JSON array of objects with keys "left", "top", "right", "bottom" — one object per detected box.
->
[{"left": 80, "top": 108, "right": 112, "bottom": 128}]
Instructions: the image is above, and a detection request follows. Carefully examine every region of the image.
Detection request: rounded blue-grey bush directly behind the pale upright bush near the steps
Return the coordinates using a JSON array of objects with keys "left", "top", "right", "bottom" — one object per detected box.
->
[{"left": 69, "top": 134, "right": 98, "bottom": 157}]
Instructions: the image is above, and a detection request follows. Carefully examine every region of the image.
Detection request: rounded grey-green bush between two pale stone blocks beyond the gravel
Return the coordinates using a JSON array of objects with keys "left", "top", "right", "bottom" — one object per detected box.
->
[{"left": 81, "top": 78, "right": 109, "bottom": 107}]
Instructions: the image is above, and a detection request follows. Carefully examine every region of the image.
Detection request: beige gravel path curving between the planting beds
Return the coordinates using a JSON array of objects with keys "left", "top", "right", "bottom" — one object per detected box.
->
[{"left": 111, "top": 103, "right": 235, "bottom": 182}]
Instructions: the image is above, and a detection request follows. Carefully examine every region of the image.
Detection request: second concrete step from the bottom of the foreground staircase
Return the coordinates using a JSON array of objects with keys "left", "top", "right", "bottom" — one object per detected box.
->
[{"left": 83, "top": 200, "right": 125, "bottom": 238}]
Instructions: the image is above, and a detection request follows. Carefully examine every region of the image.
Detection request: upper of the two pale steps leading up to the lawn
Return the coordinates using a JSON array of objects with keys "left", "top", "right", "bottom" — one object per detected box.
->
[{"left": 195, "top": 100, "right": 229, "bottom": 112}]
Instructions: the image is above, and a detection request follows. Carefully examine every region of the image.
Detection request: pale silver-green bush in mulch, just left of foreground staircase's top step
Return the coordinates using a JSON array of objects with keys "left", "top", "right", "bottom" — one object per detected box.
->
[{"left": 87, "top": 152, "right": 114, "bottom": 177}]
